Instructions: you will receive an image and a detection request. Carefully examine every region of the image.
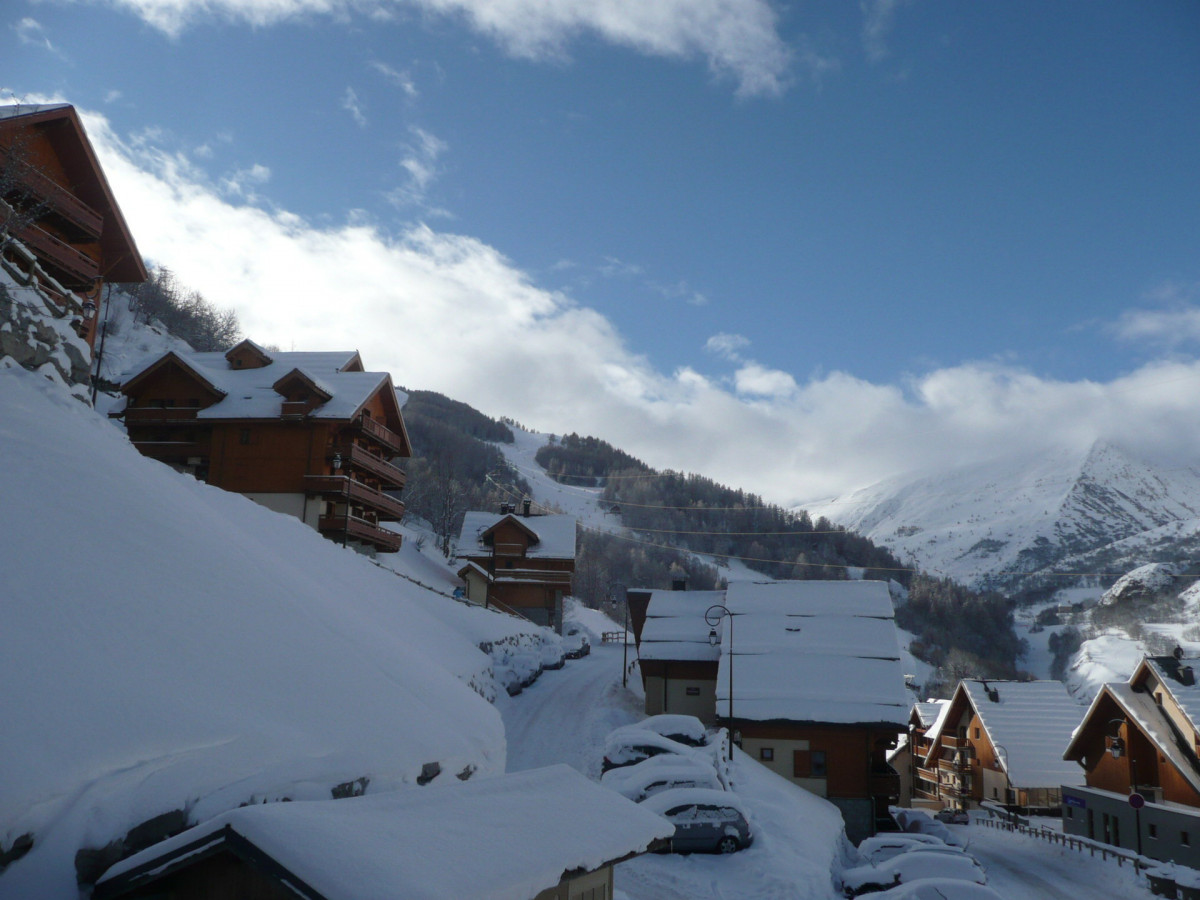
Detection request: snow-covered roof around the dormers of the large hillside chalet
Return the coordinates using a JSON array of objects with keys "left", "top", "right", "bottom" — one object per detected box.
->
[{"left": 121, "top": 346, "right": 390, "bottom": 419}]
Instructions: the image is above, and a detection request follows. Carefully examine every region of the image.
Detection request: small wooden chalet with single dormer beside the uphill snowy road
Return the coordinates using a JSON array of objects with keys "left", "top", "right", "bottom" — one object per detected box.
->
[{"left": 457, "top": 500, "right": 575, "bottom": 631}]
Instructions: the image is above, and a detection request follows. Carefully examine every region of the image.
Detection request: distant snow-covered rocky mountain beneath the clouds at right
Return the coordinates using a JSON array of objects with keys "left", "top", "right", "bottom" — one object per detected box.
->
[{"left": 808, "top": 442, "right": 1200, "bottom": 590}]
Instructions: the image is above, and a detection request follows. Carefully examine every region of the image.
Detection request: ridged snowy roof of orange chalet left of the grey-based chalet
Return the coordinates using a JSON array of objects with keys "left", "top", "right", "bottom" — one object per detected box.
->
[{"left": 959, "top": 679, "right": 1084, "bottom": 787}]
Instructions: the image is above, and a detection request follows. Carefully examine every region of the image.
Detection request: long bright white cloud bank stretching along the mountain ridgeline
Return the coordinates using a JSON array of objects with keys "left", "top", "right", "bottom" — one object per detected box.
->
[{"left": 68, "top": 103, "right": 1200, "bottom": 511}]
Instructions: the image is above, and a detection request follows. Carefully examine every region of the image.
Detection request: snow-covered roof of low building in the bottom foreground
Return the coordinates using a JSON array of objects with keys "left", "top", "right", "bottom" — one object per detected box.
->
[{"left": 101, "top": 766, "right": 674, "bottom": 900}]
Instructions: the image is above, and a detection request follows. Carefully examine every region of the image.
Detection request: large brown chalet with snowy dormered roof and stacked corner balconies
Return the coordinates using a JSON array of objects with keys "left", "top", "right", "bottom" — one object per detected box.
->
[{"left": 110, "top": 341, "right": 412, "bottom": 553}]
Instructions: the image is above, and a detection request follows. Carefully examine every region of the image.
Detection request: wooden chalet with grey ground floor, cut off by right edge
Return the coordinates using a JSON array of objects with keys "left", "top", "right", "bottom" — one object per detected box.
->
[{"left": 1062, "top": 652, "right": 1200, "bottom": 866}]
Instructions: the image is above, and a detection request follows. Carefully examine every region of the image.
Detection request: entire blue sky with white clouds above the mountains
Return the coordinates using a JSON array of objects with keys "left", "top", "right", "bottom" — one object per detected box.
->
[{"left": 7, "top": 0, "right": 1200, "bottom": 504}]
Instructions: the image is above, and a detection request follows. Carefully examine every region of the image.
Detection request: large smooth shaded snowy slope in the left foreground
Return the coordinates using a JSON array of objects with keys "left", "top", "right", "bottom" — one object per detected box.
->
[{"left": 0, "top": 367, "right": 556, "bottom": 899}]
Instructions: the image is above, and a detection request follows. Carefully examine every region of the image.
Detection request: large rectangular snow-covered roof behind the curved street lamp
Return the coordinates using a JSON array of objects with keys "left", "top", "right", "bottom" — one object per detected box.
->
[{"left": 716, "top": 581, "right": 911, "bottom": 727}]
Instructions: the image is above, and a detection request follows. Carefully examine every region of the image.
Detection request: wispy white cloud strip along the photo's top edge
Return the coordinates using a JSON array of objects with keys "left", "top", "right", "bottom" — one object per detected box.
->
[{"left": 108, "top": 0, "right": 792, "bottom": 95}]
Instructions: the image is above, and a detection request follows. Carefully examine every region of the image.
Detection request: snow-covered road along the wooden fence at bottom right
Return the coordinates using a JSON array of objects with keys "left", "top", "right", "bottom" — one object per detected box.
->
[{"left": 955, "top": 824, "right": 1153, "bottom": 900}]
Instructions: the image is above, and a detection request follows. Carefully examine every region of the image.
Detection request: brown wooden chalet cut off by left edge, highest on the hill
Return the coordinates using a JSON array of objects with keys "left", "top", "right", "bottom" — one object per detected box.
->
[{"left": 0, "top": 103, "right": 146, "bottom": 347}]
